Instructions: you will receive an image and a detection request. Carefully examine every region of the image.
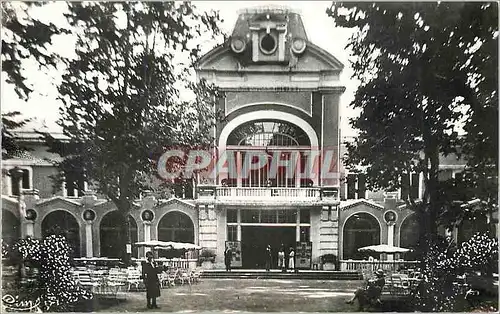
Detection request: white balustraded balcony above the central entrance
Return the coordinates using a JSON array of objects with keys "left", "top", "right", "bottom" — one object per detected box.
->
[{"left": 198, "top": 186, "right": 338, "bottom": 204}]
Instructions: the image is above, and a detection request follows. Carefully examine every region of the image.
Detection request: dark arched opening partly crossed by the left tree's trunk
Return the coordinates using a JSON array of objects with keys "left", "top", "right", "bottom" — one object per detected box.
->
[{"left": 99, "top": 210, "right": 138, "bottom": 258}]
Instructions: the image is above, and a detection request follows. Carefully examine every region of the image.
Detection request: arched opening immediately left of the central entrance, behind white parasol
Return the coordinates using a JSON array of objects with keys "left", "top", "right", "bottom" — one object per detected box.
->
[{"left": 158, "top": 211, "right": 194, "bottom": 257}]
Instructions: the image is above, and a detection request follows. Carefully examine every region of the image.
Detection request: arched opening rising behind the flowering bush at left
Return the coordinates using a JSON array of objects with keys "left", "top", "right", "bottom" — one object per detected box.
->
[{"left": 42, "top": 210, "right": 81, "bottom": 257}]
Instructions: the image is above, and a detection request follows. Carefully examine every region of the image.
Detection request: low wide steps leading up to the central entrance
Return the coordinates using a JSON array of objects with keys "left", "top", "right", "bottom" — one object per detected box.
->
[{"left": 201, "top": 269, "right": 363, "bottom": 280}]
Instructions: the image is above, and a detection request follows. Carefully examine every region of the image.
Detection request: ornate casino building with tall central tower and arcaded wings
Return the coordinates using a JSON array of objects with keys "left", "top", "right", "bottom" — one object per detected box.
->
[{"left": 2, "top": 7, "right": 494, "bottom": 269}]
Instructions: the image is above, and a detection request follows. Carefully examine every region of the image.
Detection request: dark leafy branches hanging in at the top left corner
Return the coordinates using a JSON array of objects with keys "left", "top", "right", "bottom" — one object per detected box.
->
[{"left": 0, "top": 2, "right": 68, "bottom": 159}]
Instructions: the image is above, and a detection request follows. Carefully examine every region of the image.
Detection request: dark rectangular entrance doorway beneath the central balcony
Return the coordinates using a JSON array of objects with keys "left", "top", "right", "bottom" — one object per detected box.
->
[{"left": 241, "top": 226, "right": 296, "bottom": 269}]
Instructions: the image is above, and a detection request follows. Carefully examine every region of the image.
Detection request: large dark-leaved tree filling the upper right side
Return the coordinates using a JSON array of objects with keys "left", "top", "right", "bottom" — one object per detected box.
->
[{"left": 327, "top": 2, "right": 498, "bottom": 243}]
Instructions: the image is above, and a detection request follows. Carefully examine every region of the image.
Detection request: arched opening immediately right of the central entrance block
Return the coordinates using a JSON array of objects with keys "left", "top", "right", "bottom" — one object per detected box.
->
[{"left": 343, "top": 213, "right": 380, "bottom": 259}]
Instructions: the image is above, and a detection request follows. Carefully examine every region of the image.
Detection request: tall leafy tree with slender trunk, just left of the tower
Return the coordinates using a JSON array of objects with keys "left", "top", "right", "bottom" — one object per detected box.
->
[{"left": 40, "top": 2, "right": 224, "bottom": 262}]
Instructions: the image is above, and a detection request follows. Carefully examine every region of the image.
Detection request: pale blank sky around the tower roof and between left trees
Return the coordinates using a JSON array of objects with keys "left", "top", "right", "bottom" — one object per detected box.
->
[{"left": 1, "top": 1, "right": 359, "bottom": 136}]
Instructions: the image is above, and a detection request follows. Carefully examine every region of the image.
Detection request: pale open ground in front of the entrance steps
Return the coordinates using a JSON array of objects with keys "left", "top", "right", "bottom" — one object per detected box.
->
[{"left": 85, "top": 279, "right": 360, "bottom": 312}]
